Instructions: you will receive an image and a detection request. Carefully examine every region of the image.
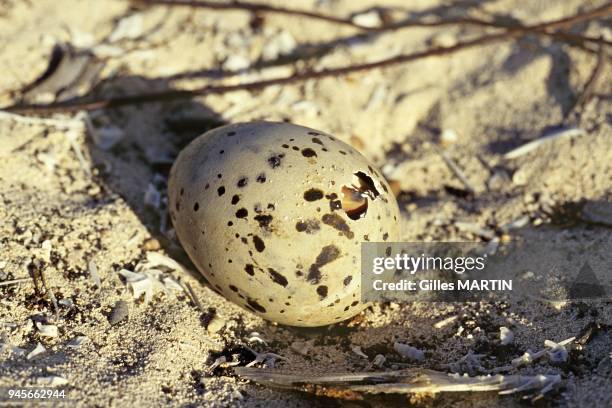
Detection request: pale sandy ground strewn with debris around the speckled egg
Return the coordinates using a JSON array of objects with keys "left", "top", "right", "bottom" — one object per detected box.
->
[{"left": 0, "top": 0, "right": 612, "bottom": 407}]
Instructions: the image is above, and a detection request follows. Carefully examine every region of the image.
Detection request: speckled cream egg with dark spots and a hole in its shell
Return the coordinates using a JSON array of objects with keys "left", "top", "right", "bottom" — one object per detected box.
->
[{"left": 168, "top": 122, "right": 399, "bottom": 326}]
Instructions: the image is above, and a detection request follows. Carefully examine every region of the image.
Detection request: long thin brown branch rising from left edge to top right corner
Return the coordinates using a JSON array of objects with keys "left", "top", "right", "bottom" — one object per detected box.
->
[{"left": 4, "top": 4, "right": 612, "bottom": 114}]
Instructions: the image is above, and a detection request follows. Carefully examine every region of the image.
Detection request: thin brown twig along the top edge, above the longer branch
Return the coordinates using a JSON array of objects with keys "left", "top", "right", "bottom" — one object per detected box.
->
[{"left": 134, "top": 0, "right": 612, "bottom": 46}]
